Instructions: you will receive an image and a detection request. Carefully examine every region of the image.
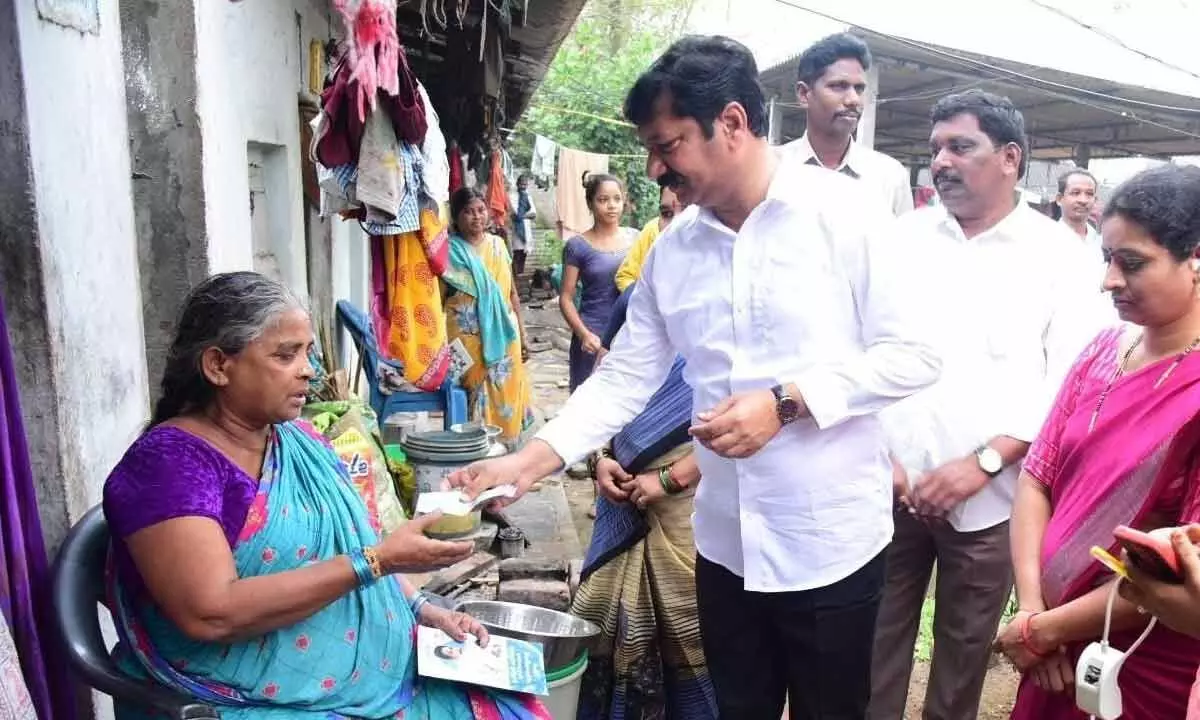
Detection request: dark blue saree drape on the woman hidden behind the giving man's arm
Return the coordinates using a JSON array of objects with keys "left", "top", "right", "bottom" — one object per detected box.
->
[{"left": 581, "top": 283, "right": 692, "bottom": 578}]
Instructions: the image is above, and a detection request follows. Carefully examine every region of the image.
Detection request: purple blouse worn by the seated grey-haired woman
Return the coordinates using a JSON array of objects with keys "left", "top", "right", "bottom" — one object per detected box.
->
[{"left": 104, "top": 425, "right": 258, "bottom": 592}]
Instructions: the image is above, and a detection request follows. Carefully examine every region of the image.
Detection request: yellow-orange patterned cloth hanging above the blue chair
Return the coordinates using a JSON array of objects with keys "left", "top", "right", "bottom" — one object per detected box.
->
[{"left": 379, "top": 210, "right": 450, "bottom": 391}]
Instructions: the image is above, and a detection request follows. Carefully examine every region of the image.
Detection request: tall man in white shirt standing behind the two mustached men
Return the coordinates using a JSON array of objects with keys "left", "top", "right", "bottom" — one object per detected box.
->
[{"left": 784, "top": 32, "right": 912, "bottom": 215}]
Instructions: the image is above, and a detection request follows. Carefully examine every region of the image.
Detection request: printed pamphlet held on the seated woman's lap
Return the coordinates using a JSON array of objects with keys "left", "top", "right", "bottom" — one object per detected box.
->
[{"left": 416, "top": 625, "right": 550, "bottom": 695}]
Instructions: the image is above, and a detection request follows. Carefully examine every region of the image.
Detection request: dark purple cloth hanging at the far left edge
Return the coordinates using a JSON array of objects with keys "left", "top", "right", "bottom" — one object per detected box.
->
[{"left": 0, "top": 291, "right": 76, "bottom": 720}]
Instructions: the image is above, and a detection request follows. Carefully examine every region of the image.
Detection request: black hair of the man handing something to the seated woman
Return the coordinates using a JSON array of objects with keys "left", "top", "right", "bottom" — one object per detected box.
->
[{"left": 625, "top": 35, "right": 767, "bottom": 138}]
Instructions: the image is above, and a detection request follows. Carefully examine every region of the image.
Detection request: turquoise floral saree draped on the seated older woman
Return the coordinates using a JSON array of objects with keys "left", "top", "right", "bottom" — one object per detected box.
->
[{"left": 109, "top": 424, "right": 547, "bottom": 720}]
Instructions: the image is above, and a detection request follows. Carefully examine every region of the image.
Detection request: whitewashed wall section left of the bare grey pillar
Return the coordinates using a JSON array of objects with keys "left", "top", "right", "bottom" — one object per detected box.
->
[{"left": 0, "top": 0, "right": 149, "bottom": 718}]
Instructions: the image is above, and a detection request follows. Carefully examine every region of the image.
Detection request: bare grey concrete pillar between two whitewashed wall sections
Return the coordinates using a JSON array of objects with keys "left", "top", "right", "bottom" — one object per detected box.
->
[{"left": 120, "top": 0, "right": 209, "bottom": 397}]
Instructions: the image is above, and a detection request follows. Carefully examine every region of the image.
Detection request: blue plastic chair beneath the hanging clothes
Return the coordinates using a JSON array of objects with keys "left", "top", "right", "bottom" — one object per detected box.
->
[{"left": 337, "top": 300, "right": 467, "bottom": 430}]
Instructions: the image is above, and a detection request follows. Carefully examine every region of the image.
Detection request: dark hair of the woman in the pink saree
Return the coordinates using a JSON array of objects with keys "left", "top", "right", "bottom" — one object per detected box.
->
[{"left": 1103, "top": 164, "right": 1200, "bottom": 262}]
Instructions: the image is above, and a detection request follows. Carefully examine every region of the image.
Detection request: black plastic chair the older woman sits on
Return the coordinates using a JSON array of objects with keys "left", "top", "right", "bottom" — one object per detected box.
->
[{"left": 54, "top": 505, "right": 221, "bottom": 720}]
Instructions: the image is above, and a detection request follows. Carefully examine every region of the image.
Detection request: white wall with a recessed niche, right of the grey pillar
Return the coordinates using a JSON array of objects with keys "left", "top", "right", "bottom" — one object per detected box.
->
[{"left": 196, "top": 0, "right": 340, "bottom": 293}]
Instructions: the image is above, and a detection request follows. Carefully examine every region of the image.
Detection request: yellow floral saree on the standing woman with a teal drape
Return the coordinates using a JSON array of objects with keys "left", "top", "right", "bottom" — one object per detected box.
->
[{"left": 445, "top": 235, "right": 533, "bottom": 445}]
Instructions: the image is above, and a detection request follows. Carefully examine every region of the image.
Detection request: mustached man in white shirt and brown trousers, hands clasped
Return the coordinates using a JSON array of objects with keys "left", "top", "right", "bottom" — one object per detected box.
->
[{"left": 870, "top": 90, "right": 1109, "bottom": 720}]
